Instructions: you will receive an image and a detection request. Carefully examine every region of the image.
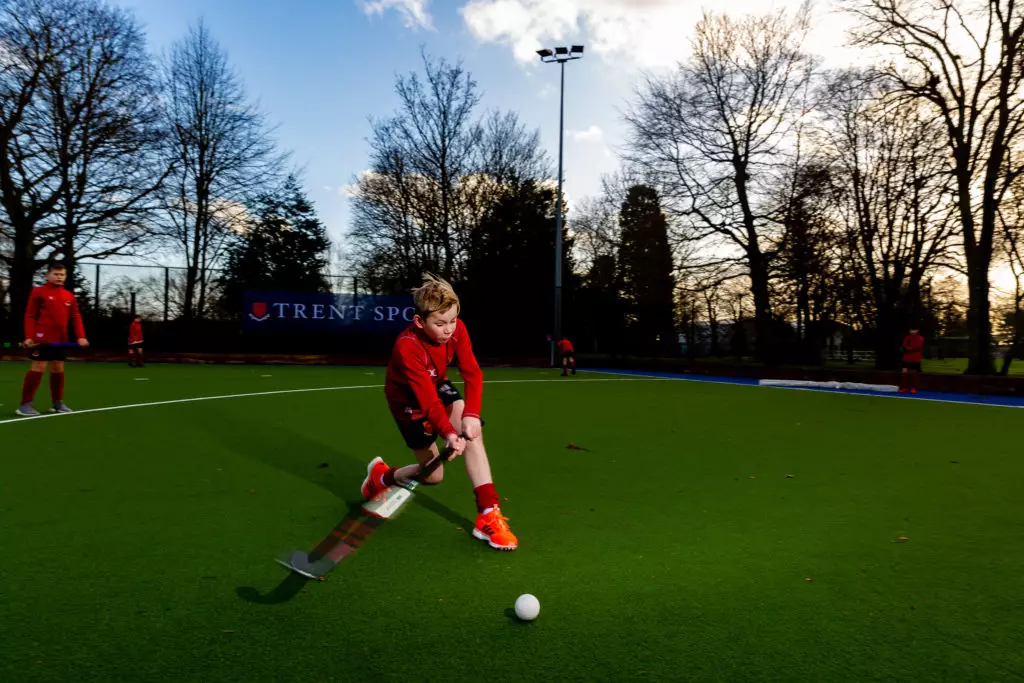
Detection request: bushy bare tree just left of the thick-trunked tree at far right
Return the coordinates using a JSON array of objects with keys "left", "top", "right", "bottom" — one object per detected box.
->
[{"left": 824, "top": 70, "right": 956, "bottom": 370}]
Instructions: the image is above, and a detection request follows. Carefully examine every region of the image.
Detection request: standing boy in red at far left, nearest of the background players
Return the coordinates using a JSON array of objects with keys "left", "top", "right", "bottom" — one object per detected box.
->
[{"left": 15, "top": 263, "right": 89, "bottom": 418}]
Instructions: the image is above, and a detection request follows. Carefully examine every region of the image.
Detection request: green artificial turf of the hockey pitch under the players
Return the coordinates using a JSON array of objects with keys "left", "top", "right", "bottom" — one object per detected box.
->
[{"left": 0, "top": 364, "right": 1024, "bottom": 682}]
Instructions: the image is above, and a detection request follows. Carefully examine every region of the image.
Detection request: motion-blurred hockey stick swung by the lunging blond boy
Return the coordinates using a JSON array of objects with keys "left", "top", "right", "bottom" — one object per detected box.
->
[{"left": 278, "top": 449, "right": 454, "bottom": 579}]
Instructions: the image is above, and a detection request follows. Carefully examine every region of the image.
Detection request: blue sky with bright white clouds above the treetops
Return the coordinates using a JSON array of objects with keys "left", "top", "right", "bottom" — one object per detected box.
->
[{"left": 119, "top": 0, "right": 849, "bottom": 252}]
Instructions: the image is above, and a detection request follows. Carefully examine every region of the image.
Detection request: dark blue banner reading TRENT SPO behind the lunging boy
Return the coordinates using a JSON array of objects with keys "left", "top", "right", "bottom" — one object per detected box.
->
[{"left": 242, "top": 291, "right": 416, "bottom": 333}]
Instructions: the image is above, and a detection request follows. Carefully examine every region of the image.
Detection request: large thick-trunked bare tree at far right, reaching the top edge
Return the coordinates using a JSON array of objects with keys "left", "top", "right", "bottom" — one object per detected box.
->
[{"left": 848, "top": 0, "right": 1024, "bottom": 374}]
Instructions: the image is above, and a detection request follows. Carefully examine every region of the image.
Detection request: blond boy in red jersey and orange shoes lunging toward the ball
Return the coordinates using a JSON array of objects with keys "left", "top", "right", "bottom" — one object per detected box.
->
[{"left": 362, "top": 275, "right": 519, "bottom": 550}]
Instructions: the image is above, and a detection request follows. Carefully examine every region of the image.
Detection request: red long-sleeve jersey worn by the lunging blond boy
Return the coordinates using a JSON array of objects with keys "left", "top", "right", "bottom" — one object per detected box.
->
[{"left": 384, "top": 321, "right": 483, "bottom": 436}]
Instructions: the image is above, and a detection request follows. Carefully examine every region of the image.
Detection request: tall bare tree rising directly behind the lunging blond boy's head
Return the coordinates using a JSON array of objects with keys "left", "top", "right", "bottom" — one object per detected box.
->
[{"left": 350, "top": 53, "right": 483, "bottom": 287}]
